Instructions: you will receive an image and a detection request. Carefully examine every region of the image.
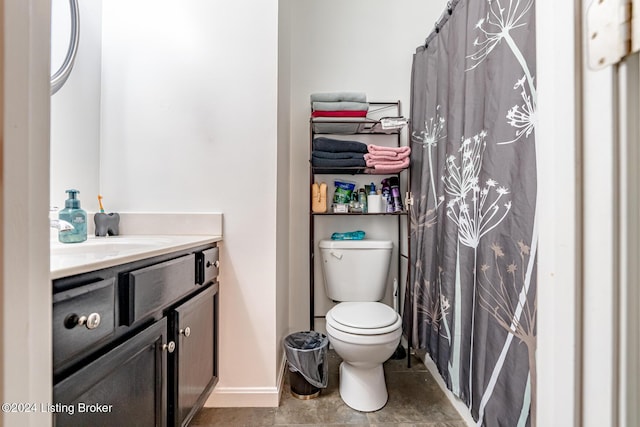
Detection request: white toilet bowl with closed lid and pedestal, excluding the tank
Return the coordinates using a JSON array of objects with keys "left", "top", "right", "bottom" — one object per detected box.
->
[{"left": 326, "top": 302, "right": 402, "bottom": 412}]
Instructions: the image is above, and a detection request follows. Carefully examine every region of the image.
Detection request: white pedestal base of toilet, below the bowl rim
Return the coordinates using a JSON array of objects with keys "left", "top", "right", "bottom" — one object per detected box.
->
[{"left": 340, "top": 362, "right": 389, "bottom": 412}]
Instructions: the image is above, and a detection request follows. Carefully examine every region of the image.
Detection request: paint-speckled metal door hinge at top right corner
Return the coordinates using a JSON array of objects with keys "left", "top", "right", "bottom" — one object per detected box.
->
[{"left": 586, "top": 0, "right": 640, "bottom": 70}]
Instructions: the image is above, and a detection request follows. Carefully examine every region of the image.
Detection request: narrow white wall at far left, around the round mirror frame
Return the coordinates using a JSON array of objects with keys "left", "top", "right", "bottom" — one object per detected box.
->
[{"left": 50, "top": 0, "right": 102, "bottom": 211}]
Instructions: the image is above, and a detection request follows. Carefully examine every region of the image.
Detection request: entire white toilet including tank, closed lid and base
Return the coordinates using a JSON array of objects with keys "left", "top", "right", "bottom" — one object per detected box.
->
[{"left": 319, "top": 240, "right": 402, "bottom": 412}]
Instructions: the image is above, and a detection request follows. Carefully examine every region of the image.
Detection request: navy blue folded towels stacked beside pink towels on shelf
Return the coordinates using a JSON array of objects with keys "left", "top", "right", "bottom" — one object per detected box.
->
[{"left": 311, "top": 137, "right": 367, "bottom": 168}]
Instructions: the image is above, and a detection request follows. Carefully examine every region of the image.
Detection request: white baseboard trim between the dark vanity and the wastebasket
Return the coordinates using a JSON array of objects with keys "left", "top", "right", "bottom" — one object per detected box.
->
[{"left": 204, "top": 357, "right": 286, "bottom": 408}]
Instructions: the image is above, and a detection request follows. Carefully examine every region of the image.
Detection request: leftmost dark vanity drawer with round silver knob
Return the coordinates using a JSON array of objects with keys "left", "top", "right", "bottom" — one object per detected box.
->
[{"left": 53, "top": 278, "right": 115, "bottom": 371}]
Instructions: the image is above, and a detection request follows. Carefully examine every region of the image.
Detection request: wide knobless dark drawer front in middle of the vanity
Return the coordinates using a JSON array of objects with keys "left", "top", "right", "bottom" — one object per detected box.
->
[{"left": 120, "top": 254, "right": 196, "bottom": 326}]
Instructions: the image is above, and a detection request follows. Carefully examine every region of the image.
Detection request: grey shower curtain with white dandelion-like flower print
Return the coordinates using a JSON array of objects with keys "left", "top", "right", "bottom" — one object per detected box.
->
[{"left": 404, "top": 0, "right": 538, "bottom": 426}]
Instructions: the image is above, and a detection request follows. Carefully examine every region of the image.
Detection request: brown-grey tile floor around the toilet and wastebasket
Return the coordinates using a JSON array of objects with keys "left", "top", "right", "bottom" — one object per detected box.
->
[{"left": 190, "top": 350, "right": 467, "bottom": 427}]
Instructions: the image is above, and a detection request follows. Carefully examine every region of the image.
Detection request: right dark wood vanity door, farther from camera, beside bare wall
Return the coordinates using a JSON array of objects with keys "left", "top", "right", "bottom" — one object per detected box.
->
[{"left": 169, "top": 283, "right": 218, "bottom": 426}]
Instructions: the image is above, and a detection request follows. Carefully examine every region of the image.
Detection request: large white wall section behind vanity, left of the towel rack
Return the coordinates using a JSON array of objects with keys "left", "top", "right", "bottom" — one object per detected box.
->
[{"left": 100, "top": 0, "right": 280, "bottom": 406}]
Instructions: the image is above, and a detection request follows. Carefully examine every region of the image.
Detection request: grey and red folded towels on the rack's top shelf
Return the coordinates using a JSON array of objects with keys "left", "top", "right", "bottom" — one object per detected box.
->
[{"left": 311, "top": 92, "right": 369, "bottom": 118}]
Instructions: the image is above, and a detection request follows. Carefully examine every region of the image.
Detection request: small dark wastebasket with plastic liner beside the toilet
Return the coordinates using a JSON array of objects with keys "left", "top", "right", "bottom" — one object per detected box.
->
[{"left": 284, "top": 331, "right": 329, "bottom": 399}]
